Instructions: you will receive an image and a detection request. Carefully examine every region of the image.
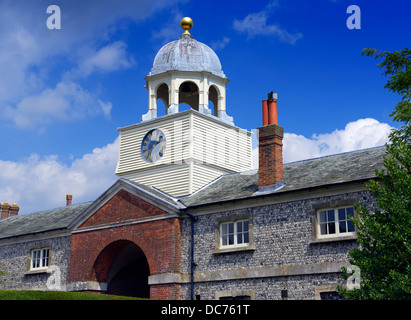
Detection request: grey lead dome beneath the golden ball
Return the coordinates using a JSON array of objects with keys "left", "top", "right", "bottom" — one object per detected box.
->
[{"left": 149, "top": 34, "right": 226, "bottom": 78}]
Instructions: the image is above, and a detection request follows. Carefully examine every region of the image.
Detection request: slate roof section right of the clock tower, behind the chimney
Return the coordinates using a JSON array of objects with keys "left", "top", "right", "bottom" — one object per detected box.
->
[{"left": 180, "top": 147, "right": 385, "bottom": 207}]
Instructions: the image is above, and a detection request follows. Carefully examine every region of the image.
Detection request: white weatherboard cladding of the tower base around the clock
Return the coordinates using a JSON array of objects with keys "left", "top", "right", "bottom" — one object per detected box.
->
[{"left": 116, "top": 110, "right": 252, "bottom": 197}]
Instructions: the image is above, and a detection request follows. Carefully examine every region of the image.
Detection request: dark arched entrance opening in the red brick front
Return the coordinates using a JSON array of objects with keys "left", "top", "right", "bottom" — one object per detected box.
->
[{"left": 93, "top": 240, "right": 150, "bottom": 298}]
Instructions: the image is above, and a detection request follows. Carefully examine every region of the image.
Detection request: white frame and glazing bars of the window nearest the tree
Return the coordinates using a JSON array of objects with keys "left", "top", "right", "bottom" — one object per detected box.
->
[{"left": 316, "top": 205, "right": 356, "bottom": 239}]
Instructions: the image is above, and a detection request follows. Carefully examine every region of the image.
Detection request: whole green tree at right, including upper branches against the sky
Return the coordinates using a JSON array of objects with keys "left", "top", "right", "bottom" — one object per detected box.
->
[{"left": 338, "top": 49, "right": 411, "bottom": 300}]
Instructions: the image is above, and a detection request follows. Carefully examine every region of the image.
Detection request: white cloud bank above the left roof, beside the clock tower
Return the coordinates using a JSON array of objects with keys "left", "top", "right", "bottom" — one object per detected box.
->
[{"left": 0, "top": 138, "right": 118, "bottom": 214}]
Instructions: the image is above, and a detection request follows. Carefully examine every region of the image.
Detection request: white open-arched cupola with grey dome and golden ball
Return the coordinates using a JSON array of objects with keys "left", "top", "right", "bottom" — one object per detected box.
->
[{"left": 142, "top": 18, "right": 233, "bottom": 124}]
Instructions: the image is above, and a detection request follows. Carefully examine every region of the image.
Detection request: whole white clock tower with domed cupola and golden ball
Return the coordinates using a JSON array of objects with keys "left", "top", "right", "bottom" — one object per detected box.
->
[{"left": 116, "top": 18, "right": 252, "bottom": 197}]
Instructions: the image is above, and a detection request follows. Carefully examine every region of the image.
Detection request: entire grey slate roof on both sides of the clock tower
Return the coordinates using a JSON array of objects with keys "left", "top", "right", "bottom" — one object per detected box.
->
[{"left": 0, "top": 147, "right": 385, "bottom": 240}]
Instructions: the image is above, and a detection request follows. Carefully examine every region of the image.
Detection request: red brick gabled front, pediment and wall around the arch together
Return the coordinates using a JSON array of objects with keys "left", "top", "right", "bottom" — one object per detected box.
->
[{"left": 69, "top": 190, "right": 181, "bottom": 299}]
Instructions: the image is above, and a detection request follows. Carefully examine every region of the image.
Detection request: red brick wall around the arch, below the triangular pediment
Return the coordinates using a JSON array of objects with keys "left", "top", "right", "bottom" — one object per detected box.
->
[{"left": 69, "top": 218, "right": 181, "bottom": 300}]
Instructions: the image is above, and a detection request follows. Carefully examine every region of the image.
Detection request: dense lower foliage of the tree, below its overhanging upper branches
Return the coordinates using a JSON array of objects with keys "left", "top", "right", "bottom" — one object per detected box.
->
[{"left": 340, "top": 143, "right": 411, "bottom": 300}]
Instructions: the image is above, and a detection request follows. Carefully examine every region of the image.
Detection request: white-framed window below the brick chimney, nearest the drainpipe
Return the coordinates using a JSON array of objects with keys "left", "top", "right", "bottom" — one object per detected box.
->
[{"left": 220, "top": 220, "right": 250, "bottom": 247}]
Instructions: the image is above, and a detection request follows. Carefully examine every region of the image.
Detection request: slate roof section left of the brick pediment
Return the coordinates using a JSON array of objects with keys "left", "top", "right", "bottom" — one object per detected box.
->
[{"left": 0, "top": 202, "right": 91, "bottom": 239}]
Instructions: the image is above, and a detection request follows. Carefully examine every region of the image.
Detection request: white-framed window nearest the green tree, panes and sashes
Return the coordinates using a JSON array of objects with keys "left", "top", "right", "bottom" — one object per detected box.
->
[{"left": 317, "top": 207, "right": 355, "bottom": 238}]
